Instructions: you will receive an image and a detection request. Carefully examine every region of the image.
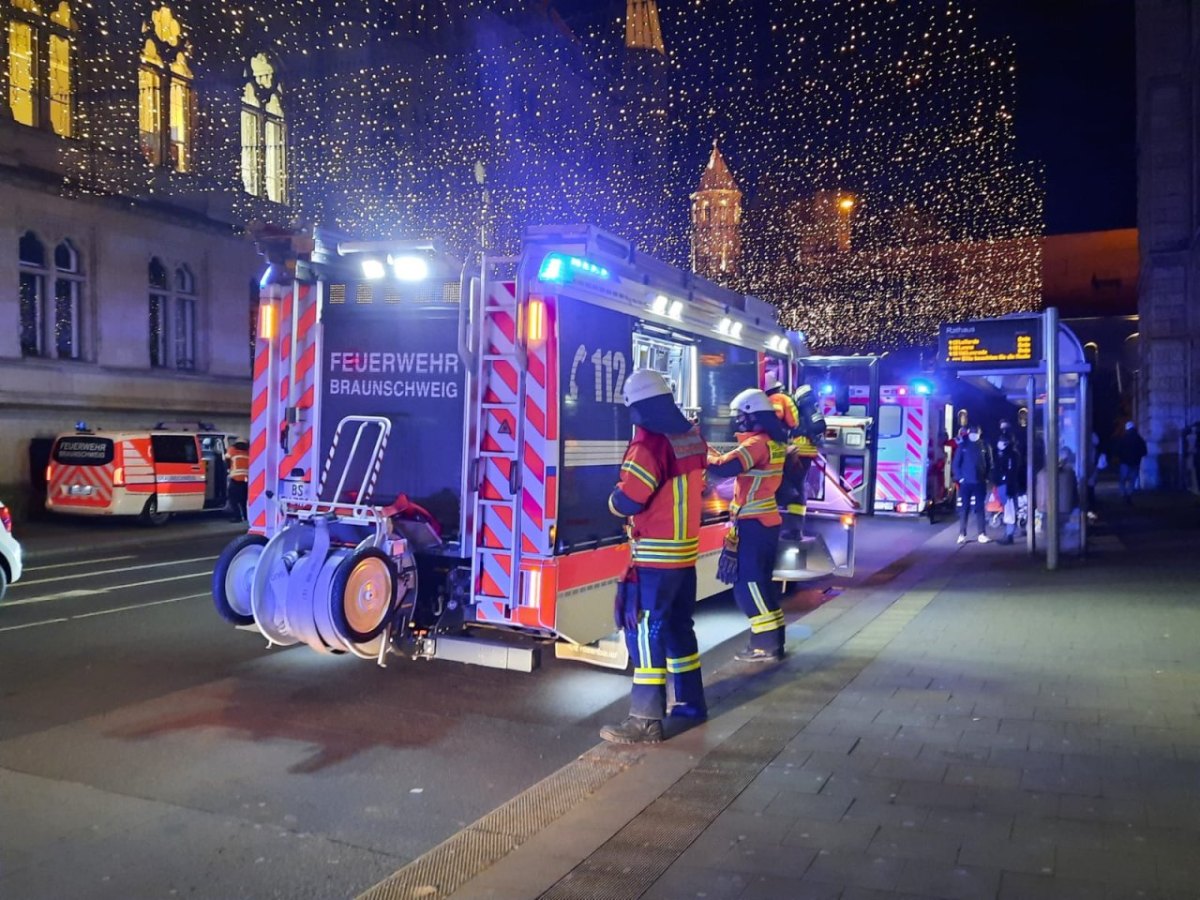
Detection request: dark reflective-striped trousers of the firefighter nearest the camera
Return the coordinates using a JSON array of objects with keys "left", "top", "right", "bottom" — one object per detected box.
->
[{"left": 625, "top": 565, "right": 704, "bottom": 719}]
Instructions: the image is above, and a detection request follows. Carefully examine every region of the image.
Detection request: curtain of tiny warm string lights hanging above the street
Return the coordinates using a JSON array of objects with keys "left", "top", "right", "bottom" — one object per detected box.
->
[{"left": 56, "top": 0, "right": 1043, "bottom": 350}]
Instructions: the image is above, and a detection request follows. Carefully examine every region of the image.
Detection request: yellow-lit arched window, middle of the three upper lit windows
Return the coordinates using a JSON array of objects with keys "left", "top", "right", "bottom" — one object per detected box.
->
[{"left": 138, "top": 6, "right": 193, "bottom": 172}]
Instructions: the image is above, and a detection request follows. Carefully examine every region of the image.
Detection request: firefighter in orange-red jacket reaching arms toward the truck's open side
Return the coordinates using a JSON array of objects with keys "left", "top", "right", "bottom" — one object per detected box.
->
[{"left": 708, "top": 389, "right": 787, "bottom": 662}]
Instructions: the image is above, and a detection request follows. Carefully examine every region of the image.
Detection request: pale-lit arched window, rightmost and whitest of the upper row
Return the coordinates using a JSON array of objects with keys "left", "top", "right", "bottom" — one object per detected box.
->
[{"left": 241, "top": 53, "right": 288, "bottom": 203}]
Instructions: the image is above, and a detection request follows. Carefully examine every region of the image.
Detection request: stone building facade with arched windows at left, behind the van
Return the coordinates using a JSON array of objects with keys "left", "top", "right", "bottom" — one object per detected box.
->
[{"left": 0, "top": 0, "right": 276, "bottom": 515}]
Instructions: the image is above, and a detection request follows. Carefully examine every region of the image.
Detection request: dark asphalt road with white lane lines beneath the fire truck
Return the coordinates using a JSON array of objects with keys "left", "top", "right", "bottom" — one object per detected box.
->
[{"left": 0, "top": 520, "right": 934, "bottom": 900}]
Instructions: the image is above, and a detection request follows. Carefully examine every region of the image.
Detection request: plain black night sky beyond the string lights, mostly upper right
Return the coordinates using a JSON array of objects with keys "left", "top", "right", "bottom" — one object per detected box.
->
[{"left": 554, "top": 0, "right": 1136, "bottom": 234}]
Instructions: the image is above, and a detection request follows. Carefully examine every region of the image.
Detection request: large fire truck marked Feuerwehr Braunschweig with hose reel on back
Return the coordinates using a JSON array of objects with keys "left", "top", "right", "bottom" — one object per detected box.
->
[{"left": 212, "top": 226, "right": 854, "bottom": 671}]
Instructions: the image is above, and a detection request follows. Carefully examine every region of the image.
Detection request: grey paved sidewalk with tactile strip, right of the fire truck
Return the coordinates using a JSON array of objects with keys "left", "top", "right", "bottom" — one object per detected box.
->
[{"left": 364, "top": 496, "right": 1200, "bottom": 900}]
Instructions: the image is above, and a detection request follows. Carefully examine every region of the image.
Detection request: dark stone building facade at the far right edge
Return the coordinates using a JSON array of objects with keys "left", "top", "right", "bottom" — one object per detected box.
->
[{"left": 1136, "top": 0, "right": 1200, "bottom": 487}]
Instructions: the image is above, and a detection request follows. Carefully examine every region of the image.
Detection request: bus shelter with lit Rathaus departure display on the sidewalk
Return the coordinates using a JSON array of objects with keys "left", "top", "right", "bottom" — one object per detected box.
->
[{"left": 938, "top": 307, "right": 1096, "bottom": 569}]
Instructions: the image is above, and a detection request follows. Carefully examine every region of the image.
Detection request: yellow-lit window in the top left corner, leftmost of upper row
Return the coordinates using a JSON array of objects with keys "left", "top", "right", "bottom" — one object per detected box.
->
[{"left": 0, "top": 0, "right": 76, "bottom": 138}]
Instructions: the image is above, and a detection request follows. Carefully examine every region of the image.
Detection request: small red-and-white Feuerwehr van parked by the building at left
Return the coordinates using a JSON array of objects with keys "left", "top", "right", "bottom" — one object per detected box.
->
[{"left": 46, "top": 425, "right": 216, "bottom": 526}]
